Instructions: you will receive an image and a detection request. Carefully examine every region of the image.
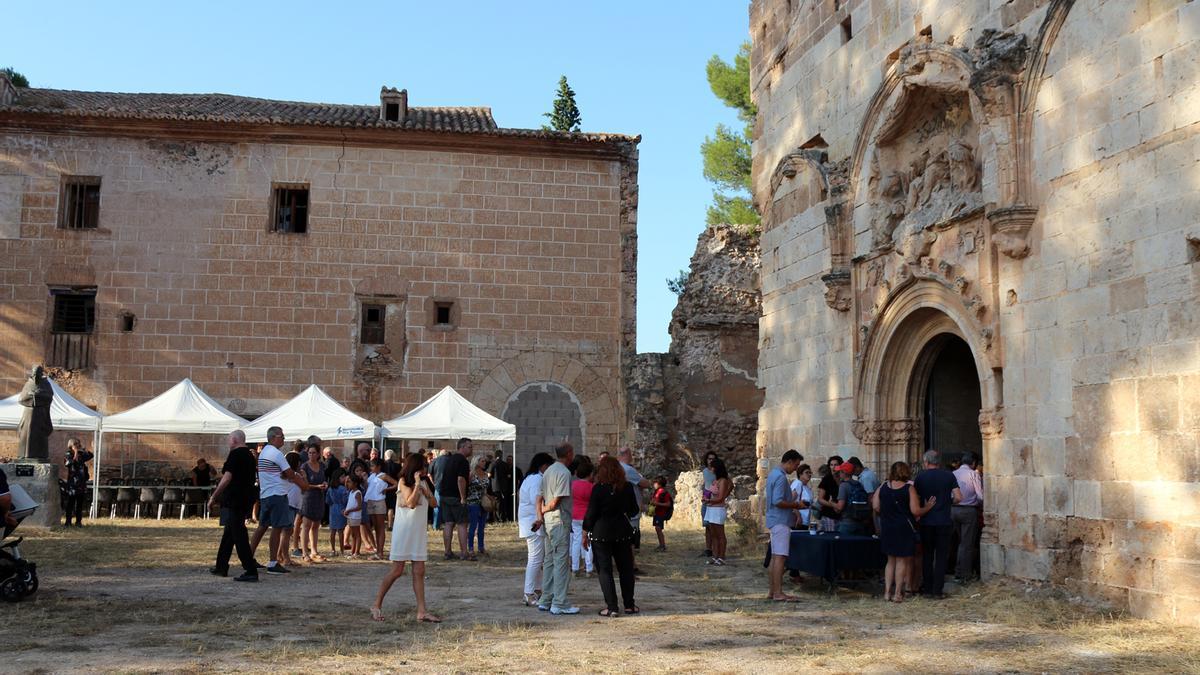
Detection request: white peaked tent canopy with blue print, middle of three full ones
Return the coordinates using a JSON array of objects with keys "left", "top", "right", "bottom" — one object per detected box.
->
[{"left": 242, "top": 384, "right": 376, "bottom": 443}]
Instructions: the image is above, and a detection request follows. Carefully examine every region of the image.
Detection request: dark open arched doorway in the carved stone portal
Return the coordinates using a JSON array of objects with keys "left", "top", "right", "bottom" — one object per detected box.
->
[{"left": 910, "top": 333, "right": 983, "bottom": 462}]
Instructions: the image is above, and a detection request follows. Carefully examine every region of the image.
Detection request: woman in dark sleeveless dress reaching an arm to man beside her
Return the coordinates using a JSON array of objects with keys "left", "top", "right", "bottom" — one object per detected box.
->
[{"left": 871, "top": 461, "right": 935, "bottom": 603}]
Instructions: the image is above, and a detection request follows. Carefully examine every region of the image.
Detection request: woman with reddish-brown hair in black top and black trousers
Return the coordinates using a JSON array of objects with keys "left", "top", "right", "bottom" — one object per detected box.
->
[{"left": 583, "top": 458, "right": 641, "bottom": 617}]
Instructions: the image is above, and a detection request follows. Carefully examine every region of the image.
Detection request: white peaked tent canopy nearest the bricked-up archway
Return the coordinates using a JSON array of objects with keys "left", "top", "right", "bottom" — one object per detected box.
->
[{"left": 383, "top": 387, "right": 517, "bottom": 441}]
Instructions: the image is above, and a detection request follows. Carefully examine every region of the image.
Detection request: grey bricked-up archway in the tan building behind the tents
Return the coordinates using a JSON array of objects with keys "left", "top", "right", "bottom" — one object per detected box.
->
[{"left": 500, "top": 382, "right": 587, "bottom": 455}]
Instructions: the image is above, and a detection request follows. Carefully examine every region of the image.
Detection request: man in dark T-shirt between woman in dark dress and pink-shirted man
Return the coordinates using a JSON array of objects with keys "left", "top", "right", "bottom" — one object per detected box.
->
[{"left": 913, "top": 450, "right": 962, "bottom": 599}]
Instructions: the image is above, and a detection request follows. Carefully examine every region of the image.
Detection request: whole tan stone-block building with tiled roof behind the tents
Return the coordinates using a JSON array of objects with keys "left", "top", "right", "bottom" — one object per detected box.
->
[{"left": 0, "top": 79, "right": 638, "bottom": 465}]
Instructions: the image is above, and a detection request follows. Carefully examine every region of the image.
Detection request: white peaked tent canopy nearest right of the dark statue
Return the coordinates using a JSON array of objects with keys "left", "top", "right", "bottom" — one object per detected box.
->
[{"left": 103, "top": 378, "right": 246, "bottom": 434}]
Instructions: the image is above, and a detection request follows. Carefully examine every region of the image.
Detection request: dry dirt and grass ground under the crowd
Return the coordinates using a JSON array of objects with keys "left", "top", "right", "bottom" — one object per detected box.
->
[{"left": 0, "top": 520, "right": 1200, "bottom": 673}]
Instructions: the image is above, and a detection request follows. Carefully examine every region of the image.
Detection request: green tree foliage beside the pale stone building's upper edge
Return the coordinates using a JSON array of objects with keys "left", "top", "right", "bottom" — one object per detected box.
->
[{"left": 700, "top": 42, "right": 761, "bottom": 228}]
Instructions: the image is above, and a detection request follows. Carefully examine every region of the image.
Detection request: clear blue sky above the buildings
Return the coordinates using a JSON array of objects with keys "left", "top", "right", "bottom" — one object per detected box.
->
[{"left": 0, "top": 0, "right": 749, "bottom": 352}]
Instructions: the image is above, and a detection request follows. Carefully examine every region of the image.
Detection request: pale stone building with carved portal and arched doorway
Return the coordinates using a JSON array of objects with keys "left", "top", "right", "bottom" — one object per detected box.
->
[{"left": 750, "top": 0, "right": 1200, "bottom": 623}]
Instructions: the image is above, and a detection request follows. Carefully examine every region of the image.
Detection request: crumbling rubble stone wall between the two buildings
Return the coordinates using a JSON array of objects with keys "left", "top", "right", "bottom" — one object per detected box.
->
[{"left": 630, "top": 226, "right": 762, "bottom": 477}]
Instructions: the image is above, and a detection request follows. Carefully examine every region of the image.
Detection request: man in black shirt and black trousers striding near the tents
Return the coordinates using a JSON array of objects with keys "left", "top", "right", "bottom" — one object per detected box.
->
[{"left": 209, "top": 430, "right": 258, "bottom": 581}]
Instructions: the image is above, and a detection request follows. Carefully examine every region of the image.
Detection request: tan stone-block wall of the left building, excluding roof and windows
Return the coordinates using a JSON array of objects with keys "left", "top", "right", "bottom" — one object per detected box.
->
[{"left": 0, "top": 131, "right": 637, "bottom": 466}]
